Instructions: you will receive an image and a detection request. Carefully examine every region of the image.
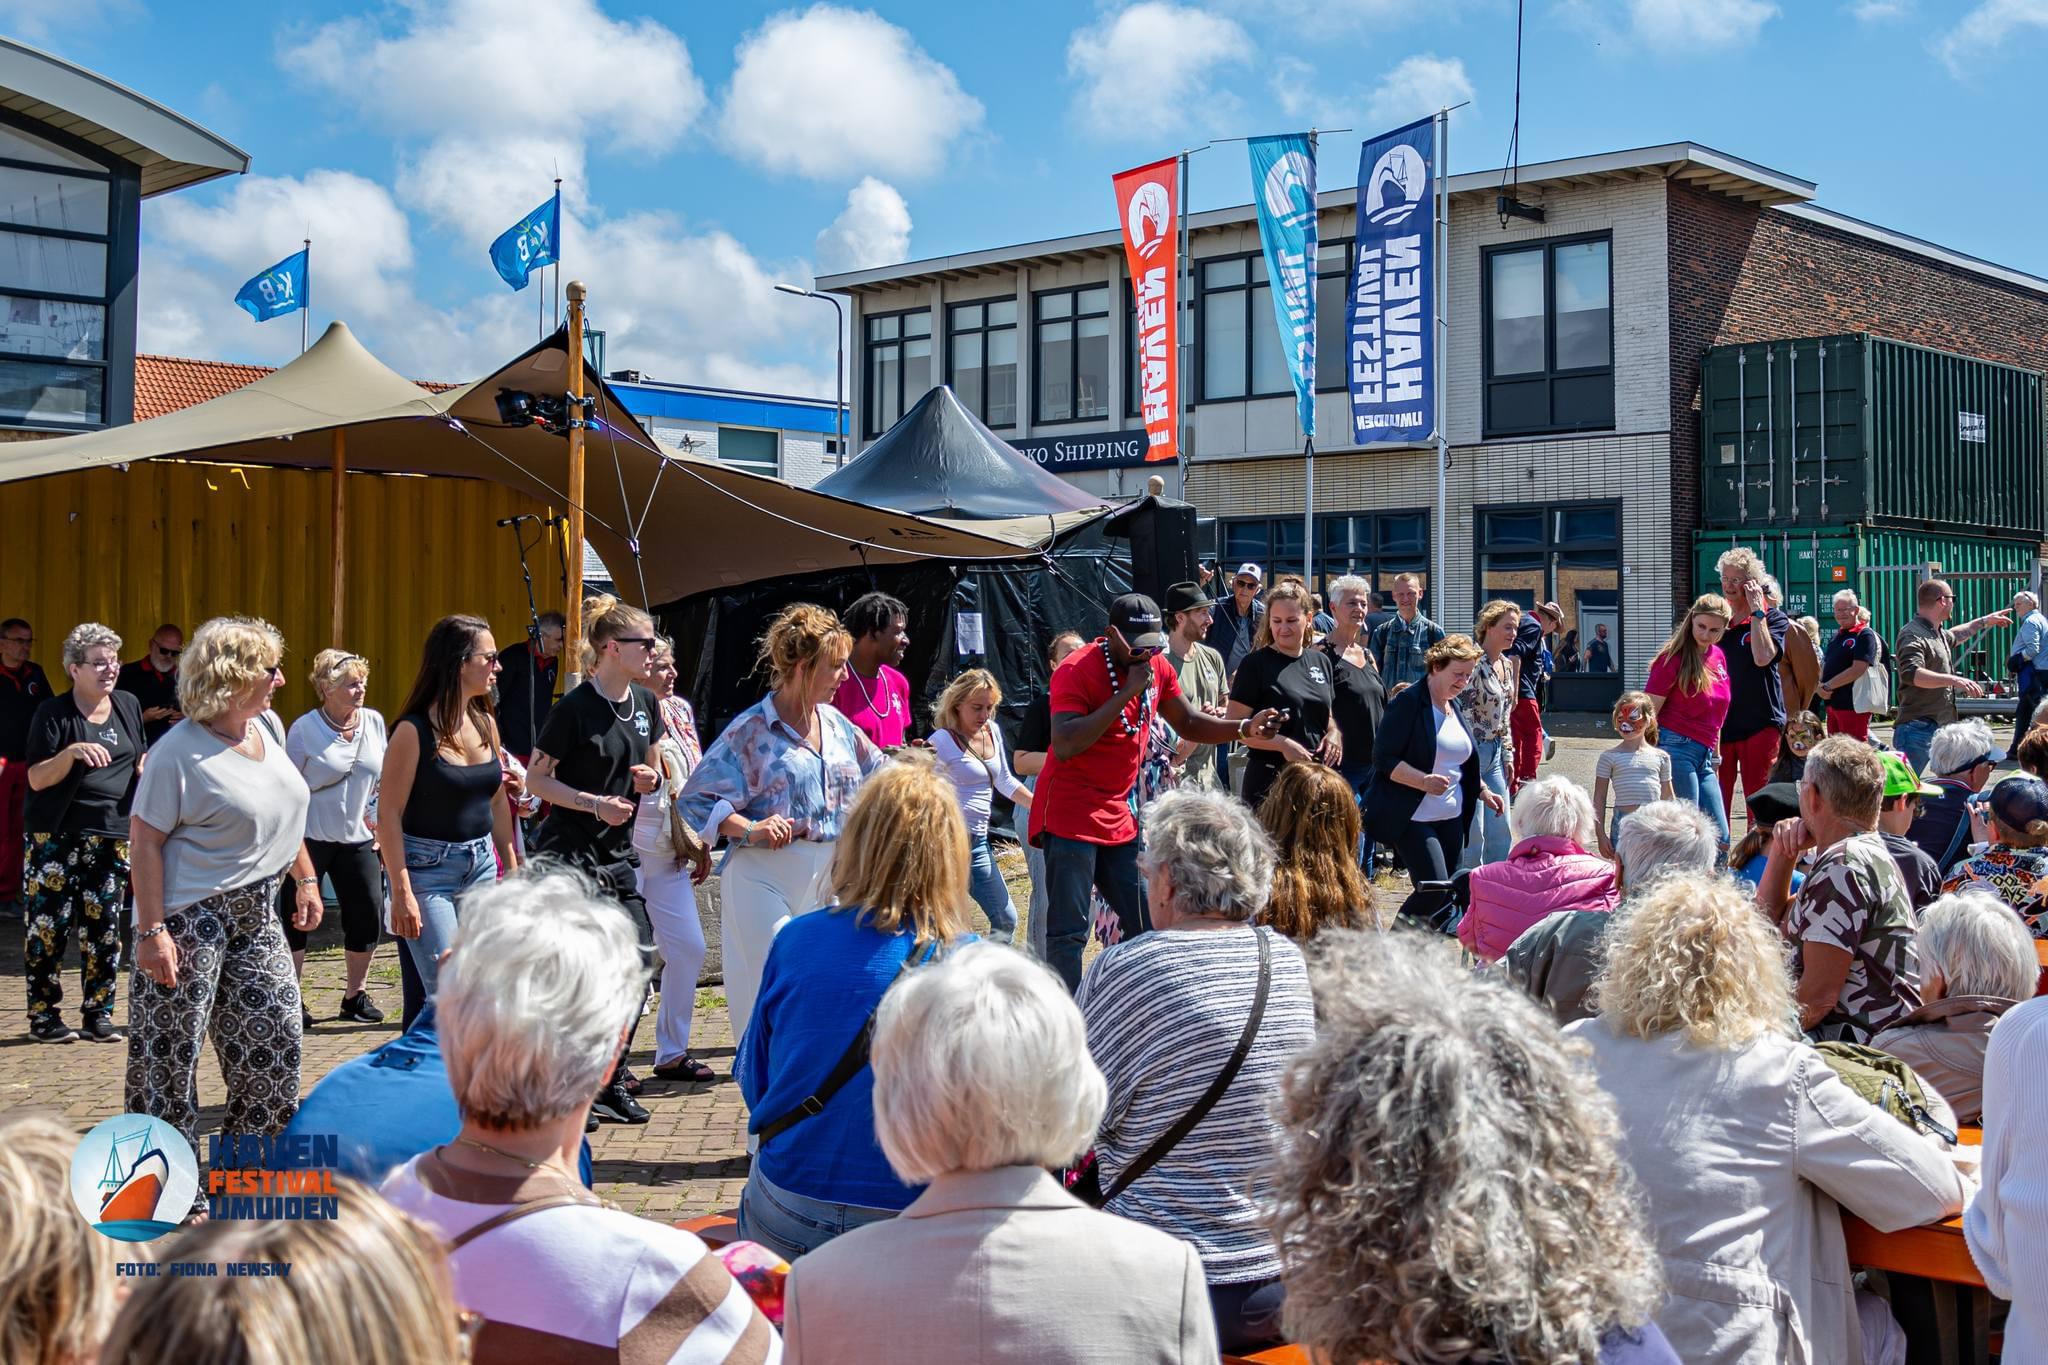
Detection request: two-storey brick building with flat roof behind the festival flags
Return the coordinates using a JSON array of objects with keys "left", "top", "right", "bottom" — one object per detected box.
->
[{"left": 817, "top": 143, "right": 2048, "bottom": 708}]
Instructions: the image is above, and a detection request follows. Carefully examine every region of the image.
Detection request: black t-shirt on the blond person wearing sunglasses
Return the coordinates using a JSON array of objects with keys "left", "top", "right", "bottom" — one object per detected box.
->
[{"left": 532, "top": 679, "right": 664, "bottom": 866}]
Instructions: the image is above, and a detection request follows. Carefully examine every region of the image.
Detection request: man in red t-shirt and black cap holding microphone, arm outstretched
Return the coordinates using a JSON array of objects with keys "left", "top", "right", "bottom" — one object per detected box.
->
[{"left": 1030, "top": 593, "right": 1280, "bottom": 990}]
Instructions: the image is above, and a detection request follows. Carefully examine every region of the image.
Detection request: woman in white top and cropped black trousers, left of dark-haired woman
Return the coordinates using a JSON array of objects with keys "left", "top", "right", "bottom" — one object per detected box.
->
[{"left": 279, "top": 649, "right": 385, "bottom": 1027}]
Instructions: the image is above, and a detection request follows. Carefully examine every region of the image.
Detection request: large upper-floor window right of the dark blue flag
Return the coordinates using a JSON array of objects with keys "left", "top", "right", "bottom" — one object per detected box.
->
[{"left": 1481, "top": 235, "right": 1614, "bottom": 436}]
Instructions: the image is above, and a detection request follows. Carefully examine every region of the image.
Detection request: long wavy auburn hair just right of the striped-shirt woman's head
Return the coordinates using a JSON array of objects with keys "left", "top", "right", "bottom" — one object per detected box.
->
[{"left": 1257, "top": 763, "right": 1380, "bottom": 943}]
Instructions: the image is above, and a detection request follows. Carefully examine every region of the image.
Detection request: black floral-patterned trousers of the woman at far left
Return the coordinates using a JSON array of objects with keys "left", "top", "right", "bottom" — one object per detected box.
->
[{"left": 23, "top": 833, "right": 127, "bottom": 1023}]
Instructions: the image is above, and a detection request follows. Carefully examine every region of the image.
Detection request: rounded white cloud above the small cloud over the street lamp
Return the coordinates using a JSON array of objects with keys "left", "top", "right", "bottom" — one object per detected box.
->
[{"left": 719, "top": 4, "right": 983, "bottom": 180}]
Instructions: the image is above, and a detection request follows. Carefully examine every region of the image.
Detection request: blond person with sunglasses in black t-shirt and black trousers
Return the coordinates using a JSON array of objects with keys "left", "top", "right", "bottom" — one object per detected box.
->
[{"left": 526, "top": 596, "right": 668, "bottom": 1124}]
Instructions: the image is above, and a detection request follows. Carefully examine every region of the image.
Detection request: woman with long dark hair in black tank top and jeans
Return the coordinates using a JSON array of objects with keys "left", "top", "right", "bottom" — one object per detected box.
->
[{"left": 377, "top": 616, "right": 518, "bottom": 1027}]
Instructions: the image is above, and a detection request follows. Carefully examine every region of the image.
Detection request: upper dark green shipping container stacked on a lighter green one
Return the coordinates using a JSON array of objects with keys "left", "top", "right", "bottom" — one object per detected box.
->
[{"left": 1700, "top": 332, "right": 2048, "bottom": 540}]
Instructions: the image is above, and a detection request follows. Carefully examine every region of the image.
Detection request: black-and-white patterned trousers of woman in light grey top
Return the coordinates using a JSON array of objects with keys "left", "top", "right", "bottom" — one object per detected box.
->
[{"left": 123, "top": 876, "right": 299, "bottom": 1201}]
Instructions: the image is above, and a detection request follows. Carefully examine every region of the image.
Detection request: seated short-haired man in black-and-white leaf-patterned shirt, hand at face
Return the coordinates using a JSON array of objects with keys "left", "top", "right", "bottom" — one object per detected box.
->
[{"left": 1757, "top": 735, "right": 1921, "bottom": 1044}]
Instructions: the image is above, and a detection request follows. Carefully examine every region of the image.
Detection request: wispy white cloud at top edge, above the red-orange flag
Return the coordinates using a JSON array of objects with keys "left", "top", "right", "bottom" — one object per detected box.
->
[{"left": 1067, "top": 0, "right": 1253, "bottom": 141}]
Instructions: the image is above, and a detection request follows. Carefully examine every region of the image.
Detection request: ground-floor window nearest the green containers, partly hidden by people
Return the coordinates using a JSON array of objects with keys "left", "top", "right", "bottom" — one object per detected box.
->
[{"left": 1473, "top": 501, "right": 1624, "bottom": 710}]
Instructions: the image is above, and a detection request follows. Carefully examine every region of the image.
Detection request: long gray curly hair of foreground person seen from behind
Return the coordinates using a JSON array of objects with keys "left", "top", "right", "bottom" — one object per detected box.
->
[{"left": 1268, "top": 931, "right": 1663, "bottom": 1365}]
